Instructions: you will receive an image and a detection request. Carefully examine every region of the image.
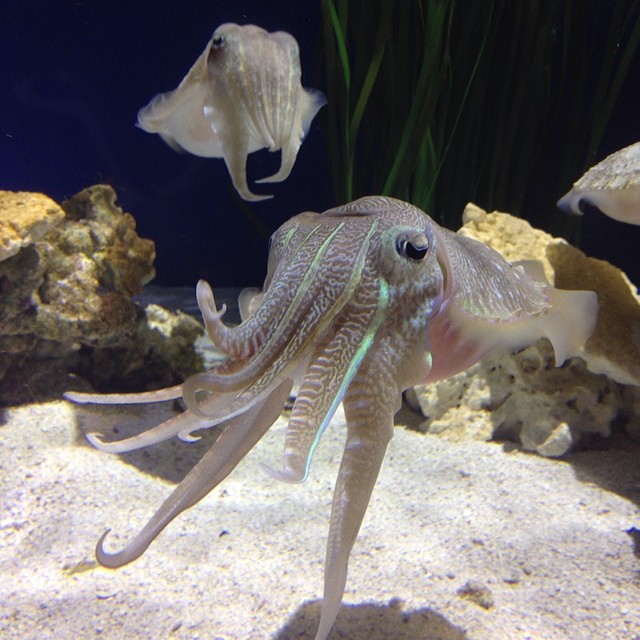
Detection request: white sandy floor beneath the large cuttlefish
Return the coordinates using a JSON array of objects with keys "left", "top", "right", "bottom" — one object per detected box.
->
[{"left": 0, "top": 292, "right": 640, "bottom": 640}]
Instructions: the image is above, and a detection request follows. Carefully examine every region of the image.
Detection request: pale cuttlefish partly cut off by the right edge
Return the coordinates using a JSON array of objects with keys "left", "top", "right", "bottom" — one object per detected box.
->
[{"left": 557, "top": 142, "right": 640, "bottom": 224}]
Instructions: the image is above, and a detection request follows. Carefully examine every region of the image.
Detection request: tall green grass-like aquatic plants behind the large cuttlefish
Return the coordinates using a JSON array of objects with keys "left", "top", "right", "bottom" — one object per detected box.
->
[{"left": 322, "top": 0, "right": 640, "bottom": 234}]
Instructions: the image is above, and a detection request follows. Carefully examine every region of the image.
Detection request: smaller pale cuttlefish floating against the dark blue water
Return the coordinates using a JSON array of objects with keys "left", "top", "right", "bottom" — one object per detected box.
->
[{"left": 138, "top": 23, "right": 326, "bottom": 200}]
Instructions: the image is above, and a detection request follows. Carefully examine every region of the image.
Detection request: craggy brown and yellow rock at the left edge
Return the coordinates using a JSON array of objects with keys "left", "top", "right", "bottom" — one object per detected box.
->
[{"left": 0, "top": 185, "right": 202, "bottom": 404}]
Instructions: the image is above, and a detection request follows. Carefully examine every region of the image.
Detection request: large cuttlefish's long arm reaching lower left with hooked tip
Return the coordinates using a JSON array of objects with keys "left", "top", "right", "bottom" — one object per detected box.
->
[{"left": 96, "top": 379, "right": 293, "bottom": 569}]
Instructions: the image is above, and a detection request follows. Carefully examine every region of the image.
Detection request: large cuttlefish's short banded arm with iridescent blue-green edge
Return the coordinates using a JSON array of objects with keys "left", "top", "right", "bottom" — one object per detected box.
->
[{"left": 262, "top": 279, "right": 388, "bottom": 482}]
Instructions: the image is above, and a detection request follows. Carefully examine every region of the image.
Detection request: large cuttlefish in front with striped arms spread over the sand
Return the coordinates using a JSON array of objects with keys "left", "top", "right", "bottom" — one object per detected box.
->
[{"left": 67, "top": 197, "right": 597, "bottom": 640}]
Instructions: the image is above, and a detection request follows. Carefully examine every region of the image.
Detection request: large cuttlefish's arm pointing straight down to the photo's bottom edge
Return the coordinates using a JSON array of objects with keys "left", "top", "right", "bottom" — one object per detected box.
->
[{"left": 316, "top": 367, "right": 401, "bottom": 640}]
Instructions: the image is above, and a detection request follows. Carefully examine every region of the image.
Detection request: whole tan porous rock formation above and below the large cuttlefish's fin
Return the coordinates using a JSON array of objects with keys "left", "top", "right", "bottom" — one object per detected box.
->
[{"left": 410, "top": 204, "right": 640, "bottom": 456}]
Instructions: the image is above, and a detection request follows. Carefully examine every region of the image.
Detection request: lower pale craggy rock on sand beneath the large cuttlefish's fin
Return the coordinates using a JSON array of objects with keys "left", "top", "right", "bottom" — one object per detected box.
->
[{"left": 414, "top": 340, "right": 633, "bottom": 457}]
